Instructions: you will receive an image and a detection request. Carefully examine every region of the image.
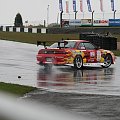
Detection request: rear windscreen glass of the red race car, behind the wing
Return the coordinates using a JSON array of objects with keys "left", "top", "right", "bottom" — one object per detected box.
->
[{"left": 50, "top": 41, "right": 76, "bottom": 48}]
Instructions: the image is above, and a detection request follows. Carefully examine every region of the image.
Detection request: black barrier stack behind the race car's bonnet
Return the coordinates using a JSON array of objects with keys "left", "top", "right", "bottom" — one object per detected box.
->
[{"left": 80, "top": 33, "right": 117, "bottom": 50}]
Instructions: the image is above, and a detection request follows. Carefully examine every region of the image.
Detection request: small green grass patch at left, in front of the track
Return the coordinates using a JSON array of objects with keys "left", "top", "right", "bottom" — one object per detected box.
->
[{"left": 0, "top": 82, "right": 37, "bottom": 96}]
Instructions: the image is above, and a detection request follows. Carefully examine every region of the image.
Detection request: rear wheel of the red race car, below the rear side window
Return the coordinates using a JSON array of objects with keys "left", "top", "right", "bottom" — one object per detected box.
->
[{"left": 74, "top": 56, "right": 83, "bottom": 69}]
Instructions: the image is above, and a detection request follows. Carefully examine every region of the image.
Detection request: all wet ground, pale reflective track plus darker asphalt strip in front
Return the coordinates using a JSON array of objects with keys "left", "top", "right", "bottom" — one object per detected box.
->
[{"left": 0, "top": 40, "right": 120, "bottom": 120}]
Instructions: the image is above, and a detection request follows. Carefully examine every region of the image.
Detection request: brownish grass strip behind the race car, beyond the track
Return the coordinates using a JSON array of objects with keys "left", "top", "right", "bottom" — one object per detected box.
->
[{"left": 0, "top": 32, "right": 79, "bottom": 44}]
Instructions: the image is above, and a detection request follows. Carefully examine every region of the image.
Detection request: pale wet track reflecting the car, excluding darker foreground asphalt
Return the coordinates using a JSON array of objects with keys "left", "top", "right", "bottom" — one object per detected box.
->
[{"left": 0, "top": 40, "right": 120, "bottom": 95}]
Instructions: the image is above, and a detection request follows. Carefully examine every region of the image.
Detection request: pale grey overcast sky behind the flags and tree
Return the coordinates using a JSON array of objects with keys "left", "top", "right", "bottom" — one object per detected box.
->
[{"left": 0, "top": 0, "right": 120, "bottom": 25}]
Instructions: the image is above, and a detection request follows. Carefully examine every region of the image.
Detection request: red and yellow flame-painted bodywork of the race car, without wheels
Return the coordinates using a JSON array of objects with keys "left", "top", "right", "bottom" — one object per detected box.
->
[{"left": 36, "top": 40, "right": 116, "bottom": 68}]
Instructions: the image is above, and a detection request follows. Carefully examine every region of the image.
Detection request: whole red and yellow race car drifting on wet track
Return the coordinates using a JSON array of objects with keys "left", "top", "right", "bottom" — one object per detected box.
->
[{"left": 36, "top": 40, "right": 116, "bottom": 69}]
